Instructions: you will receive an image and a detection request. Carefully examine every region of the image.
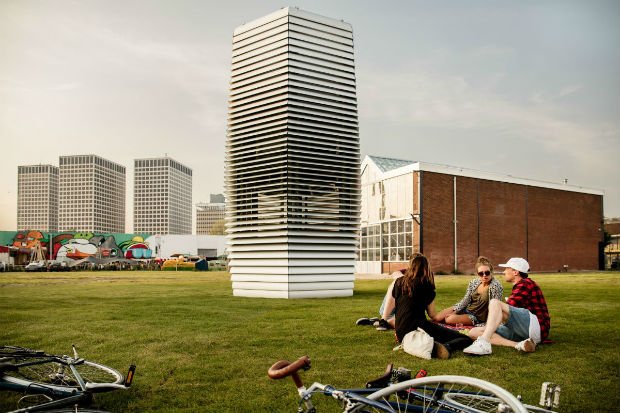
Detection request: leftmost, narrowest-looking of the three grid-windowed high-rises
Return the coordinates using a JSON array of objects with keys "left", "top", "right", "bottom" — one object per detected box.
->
[{"left": 17, "top": 165, "right": 58, "bottom": 232}]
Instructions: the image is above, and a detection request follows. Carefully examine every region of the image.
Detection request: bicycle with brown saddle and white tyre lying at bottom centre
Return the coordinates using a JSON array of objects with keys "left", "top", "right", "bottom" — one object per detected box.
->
[{"left": 268, "top": 356, "right": 559, "bottom": 413}]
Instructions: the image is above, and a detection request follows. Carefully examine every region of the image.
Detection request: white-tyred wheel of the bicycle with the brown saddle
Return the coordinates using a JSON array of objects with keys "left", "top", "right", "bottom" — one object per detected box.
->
[{"left": 352, "top": 376, "right": 527, "bottom": 413}]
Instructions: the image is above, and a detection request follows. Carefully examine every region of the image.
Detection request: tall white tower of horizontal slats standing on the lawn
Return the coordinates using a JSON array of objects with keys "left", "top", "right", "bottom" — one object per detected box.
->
[{"left": 226, "top": 7, "right": 360, "bottom": 298}]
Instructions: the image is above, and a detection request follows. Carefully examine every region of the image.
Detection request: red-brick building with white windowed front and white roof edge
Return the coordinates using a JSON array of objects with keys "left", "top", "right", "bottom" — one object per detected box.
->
[{"left": 357, "top": 156, "right": 603, "bottom": 273}]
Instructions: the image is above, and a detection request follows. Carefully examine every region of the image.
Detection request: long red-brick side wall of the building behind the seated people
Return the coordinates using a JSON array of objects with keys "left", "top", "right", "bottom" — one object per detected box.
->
[{"left": 421, "top": 172, "right": 602, "bottom": 273}]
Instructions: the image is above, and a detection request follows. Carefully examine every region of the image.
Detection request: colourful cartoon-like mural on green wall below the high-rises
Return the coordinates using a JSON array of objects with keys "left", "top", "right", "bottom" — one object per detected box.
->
[{"left": 0, "top": 231, "right": 155, "bottom": 260}]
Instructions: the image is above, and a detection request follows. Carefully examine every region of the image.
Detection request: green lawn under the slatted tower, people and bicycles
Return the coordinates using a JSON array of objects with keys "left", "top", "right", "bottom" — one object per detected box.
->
[{"left": 0, "top": 272, "right": 620, "bottom": 412}]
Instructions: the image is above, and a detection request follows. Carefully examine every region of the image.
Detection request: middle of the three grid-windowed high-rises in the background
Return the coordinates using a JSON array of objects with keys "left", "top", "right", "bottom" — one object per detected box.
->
[{"left": 58, "top": 155, "right": 125, "bottom": 234}]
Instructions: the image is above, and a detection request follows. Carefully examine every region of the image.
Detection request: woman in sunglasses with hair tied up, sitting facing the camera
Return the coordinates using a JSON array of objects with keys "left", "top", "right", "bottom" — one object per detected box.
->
[{"left": 433, "top": 257, "right": 504, "bottom": 326}]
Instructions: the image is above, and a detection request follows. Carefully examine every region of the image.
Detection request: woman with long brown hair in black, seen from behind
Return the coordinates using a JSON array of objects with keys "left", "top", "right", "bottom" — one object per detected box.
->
[{"left": 385, "top": 254, "right": 472, "bottom": 359}]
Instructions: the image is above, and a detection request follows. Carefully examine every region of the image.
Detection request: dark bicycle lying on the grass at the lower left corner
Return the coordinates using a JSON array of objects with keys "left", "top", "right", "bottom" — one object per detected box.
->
[{"left": 0, "top": 345, "right": 136, "bottom": 413}]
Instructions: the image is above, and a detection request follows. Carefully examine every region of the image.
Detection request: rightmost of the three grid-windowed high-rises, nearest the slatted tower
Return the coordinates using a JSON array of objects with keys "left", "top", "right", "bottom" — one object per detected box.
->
[{"left": 133, "top": 157, "right": 192, "bottom": 234}]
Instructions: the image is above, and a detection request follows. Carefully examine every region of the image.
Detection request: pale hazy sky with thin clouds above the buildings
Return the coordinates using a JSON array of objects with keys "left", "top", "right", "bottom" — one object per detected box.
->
[{"left": 0, "top": 0, "right": 620, "bottom": 231}]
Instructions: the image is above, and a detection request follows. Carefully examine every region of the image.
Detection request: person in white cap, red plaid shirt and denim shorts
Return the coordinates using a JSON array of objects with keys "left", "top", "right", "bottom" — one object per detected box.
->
[{"left": 463, "top": 258, "right": 551, "bottom": 356}]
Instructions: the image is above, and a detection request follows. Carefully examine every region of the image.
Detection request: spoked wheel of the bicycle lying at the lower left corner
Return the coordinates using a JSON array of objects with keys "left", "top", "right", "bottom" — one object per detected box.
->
[{"left": 0, "top": 347, "right": 125, "bottom": 390}]
